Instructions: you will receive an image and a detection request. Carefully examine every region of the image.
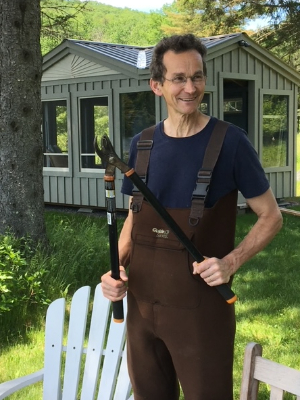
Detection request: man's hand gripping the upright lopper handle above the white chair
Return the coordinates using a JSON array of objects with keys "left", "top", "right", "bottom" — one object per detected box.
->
[{"left": 101, "top": 266, "right": 128, "bottom": 301}]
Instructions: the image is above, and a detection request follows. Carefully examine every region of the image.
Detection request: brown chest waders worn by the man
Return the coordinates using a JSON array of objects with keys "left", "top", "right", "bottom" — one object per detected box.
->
[{"left": 127, "top": 122, "right": 237, "bottom": 400}]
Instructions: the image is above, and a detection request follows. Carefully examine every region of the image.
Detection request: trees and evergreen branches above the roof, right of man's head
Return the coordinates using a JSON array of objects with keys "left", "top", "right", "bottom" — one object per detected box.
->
[{"left": 162, "top": 0, "right": 300, "bottom": 69}]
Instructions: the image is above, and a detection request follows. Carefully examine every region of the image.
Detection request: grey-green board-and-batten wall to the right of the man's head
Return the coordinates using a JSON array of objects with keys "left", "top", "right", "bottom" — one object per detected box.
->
[{"left": 207, "top": 47, "right": 298, "bottom": 202}]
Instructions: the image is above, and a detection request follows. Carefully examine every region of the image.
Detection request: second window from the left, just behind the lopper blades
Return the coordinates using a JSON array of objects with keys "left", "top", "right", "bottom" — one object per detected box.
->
[{"left": 80, "top": 96, "right": 109, "bottom": 169}]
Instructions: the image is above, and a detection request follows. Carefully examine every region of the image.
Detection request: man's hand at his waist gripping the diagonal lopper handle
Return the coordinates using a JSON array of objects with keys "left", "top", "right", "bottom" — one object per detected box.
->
[{"left": 193, "top": 257, "right": 231, "bottom": 286}]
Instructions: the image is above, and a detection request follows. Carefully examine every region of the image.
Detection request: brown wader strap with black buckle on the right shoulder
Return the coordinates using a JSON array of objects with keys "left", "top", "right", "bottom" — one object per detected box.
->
[{"left": 189, "top": 120, "right": 229, "bottom": 225}]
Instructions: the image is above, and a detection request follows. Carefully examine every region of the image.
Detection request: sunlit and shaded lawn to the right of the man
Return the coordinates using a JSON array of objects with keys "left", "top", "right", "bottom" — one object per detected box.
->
[{"left": 233, "top": 214, "right": 300, "bottom": 400}]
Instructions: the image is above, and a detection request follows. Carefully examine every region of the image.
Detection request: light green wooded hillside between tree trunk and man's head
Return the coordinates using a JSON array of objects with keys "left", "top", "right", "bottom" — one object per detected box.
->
[{"left": 41, "top": 0, "right": 165, "bottom": 54}]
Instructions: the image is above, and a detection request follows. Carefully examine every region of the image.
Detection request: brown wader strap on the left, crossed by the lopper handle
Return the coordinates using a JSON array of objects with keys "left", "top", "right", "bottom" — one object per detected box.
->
[{"left": 130, "top": 125, "right": 155, "bottom": 212}]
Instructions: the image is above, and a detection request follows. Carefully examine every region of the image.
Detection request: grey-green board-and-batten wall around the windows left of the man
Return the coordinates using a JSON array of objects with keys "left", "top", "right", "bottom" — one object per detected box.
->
[{"left": 42, "top": 67, "right": 150, "bottom": 209}]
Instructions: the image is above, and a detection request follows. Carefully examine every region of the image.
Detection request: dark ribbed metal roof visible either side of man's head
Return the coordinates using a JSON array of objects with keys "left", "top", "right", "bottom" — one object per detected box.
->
[{"left": 67, "top": 33, "right": 241, "bottom": 69}]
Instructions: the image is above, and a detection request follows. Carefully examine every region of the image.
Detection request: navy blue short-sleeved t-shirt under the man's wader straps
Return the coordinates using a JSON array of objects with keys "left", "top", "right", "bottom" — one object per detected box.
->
[{"left": 121, "top": 117, "right": 269, "bottom": 208}]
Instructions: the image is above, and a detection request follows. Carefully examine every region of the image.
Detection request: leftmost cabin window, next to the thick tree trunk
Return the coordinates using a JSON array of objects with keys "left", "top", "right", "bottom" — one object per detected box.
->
[{"left": 42, "top": 100, "right": 68, "bottom": 168}]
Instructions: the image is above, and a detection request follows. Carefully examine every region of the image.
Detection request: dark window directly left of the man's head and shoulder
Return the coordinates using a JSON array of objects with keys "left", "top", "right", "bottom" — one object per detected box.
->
[{"left": 120, "top": 91, "right": 156, "bottom": 163}]
